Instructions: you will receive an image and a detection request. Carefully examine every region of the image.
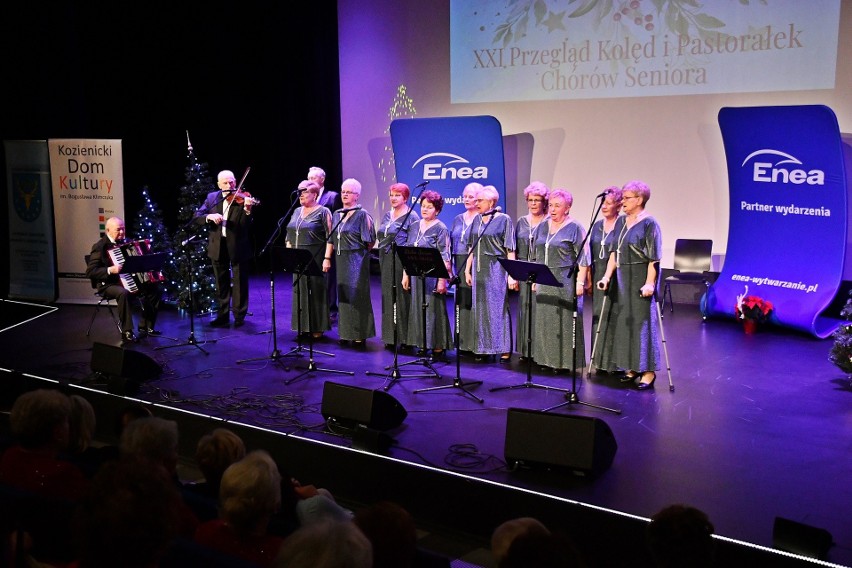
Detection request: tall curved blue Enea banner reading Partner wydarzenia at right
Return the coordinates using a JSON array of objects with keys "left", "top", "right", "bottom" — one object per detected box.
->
[{"left": 706, "top": 105, "right": 849, "bottom": 337}]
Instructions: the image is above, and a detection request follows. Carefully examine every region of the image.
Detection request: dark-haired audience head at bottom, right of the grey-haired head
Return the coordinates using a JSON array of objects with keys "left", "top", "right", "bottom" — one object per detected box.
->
[{"left": 354, "top": 501, "right": 417, "bottom": 568}]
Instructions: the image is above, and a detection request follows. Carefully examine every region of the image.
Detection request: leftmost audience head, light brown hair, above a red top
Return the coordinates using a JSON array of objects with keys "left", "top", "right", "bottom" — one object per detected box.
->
[{"left": 9, "top": 389, "right": 71, "bottom": 451}]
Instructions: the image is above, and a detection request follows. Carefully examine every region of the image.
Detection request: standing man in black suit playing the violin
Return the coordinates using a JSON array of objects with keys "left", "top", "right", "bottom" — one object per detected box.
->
[{"left": 195, "top": 170, "right": 259, "bottom": 327}]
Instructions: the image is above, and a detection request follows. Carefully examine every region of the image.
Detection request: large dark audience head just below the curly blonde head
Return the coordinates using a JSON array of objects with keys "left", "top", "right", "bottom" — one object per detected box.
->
[{"left": 74, "top": 462, "right": 185, "bottom": 568}]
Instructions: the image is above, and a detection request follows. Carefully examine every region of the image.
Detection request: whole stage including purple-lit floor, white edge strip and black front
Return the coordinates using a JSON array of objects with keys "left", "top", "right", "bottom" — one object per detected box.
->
[{"left": 0, "top": 274, "right": 852, "bottom": 566}]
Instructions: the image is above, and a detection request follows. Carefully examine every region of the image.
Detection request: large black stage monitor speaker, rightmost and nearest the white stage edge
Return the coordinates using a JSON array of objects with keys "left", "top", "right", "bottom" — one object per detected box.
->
[{"left": 505, "top": 408, "right": 618, "bottom": 477}]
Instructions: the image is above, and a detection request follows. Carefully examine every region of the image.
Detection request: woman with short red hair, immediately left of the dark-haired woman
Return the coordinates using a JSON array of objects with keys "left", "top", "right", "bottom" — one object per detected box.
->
[{"left": 377, "top": 183, "right": 420, "bottom": 347}]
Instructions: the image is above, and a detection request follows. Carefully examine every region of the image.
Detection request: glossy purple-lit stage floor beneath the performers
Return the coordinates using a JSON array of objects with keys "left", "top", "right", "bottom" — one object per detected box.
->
[{"left": 0, "top": 275, "right": 852, "bottom": 565}]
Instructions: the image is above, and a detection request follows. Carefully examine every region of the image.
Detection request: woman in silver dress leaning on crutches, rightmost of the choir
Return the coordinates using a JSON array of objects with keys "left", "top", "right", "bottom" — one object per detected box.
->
[{"left": 597, "top": 180, "right": 663, "bottom": 390}]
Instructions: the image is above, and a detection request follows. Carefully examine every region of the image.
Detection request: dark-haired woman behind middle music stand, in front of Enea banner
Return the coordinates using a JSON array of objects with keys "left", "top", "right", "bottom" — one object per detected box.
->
[{"left": 402, "top": 190, "right": 452, "bottom": 360}]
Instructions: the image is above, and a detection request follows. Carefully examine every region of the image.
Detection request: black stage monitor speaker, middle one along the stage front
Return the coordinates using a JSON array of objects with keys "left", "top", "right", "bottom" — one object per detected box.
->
[{"left": 321, "top": 382, "right": 408, "bottom": 430}]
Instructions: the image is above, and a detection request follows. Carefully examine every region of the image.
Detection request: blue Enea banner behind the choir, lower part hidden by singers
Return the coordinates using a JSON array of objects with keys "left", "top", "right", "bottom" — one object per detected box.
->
[{"left": 390, "top": 116, "right": 506, "bottom": 217}]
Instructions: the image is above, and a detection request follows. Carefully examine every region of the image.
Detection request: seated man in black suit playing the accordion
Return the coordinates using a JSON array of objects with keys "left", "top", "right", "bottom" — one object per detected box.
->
[{"left": 86, "top": 217, "right": 162, "bottom": 343}]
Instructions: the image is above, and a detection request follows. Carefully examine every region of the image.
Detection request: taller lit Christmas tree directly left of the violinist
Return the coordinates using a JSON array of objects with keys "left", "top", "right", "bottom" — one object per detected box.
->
[{"left": 163, "top": 133, "right": 216, "bottom": 314}]
